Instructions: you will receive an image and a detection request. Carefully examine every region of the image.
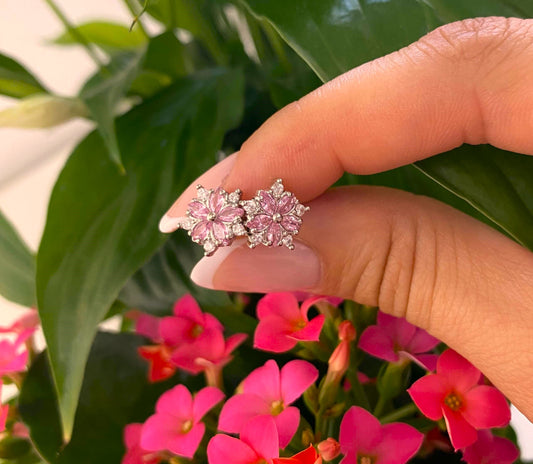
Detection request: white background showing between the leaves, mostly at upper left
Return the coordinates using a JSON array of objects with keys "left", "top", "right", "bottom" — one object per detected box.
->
[{"left": 0, "top": 0, "right": 533, "bottom": 459}]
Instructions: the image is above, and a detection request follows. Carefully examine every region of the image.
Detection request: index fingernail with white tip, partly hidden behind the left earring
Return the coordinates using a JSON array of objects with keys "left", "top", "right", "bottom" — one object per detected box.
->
[{"left": 159, "top": 153, "right": 237, "bottom": 234}]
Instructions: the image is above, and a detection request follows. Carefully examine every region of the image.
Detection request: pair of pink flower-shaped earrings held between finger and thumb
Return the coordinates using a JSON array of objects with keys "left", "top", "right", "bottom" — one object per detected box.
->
[{"left": 175, "top": 179, "right": 309, "bottom": 256}]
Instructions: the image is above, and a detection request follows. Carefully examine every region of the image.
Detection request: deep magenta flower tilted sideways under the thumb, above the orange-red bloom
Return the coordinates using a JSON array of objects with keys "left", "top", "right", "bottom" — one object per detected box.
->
[{"left": 359, "top": 311, "right": 439, "bottom": 371}]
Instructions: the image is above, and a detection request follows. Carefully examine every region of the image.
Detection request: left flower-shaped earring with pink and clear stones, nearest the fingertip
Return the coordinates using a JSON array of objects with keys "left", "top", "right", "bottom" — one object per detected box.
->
[{"left": 179, "top": 185, "right": 246, "bottom": 256}]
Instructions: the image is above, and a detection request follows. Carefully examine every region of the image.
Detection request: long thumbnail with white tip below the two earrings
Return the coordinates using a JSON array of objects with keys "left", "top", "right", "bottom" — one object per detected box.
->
[{"left": 191, "top": 240, "right": 321, "bottom": 293}]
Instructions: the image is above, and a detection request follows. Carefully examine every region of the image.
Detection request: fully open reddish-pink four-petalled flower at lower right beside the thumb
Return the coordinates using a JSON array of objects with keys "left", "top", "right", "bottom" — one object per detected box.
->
[{"left": 407, "top": 349, "right": 511, "bottom": 450}]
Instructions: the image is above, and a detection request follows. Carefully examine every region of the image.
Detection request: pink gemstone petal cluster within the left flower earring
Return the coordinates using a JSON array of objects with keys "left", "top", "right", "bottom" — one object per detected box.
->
[{"left": 187, "top": 187, "right": 244, "bottom": 246}]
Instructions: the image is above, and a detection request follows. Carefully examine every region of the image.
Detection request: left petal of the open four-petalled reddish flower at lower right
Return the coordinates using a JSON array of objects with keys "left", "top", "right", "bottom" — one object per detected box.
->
[{"left": 407, "top": 374, "right": 449, "bottom": 420}]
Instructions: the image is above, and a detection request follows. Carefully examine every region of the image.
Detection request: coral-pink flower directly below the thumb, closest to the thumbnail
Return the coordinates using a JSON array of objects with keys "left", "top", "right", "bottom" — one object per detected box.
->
[{"left": 254, "top": 292, "right": 324, "bottom": 353}]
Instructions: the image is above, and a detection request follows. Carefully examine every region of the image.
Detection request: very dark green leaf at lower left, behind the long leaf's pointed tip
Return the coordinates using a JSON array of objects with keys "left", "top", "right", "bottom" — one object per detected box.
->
[{"left": 19, "top": 332, "right": 187, "bottom": 464}]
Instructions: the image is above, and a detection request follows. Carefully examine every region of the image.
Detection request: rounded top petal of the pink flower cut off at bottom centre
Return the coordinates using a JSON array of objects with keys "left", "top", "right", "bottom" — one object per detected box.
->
[{"left": 240, "top": 416, "right": 279, "bottom": 462}]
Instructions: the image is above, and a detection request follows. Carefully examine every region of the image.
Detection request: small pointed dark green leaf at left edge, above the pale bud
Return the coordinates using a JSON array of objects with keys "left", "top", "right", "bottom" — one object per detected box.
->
[{"left": 0, "top": 53, "right": 46, "bottom": 98}]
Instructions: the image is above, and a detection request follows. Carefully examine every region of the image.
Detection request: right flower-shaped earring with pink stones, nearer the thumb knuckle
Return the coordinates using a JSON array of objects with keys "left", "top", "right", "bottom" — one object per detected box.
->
[{"left": 240, "top": 179, "right": 309, "bottom": 250}]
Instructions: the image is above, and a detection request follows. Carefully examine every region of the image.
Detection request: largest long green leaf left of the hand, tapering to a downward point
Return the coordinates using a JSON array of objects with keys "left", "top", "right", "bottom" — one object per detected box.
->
[{"left": 37, "top": 70, "right": 243, "bottom": 439}]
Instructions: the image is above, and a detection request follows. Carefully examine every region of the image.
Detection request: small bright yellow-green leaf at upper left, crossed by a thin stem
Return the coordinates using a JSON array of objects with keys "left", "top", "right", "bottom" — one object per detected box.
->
[{"left": 52, "top": 21, "right": 146, "bottom": 51}]
